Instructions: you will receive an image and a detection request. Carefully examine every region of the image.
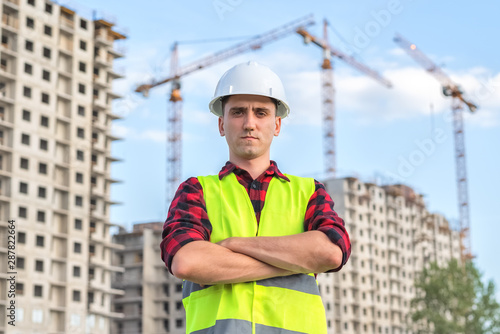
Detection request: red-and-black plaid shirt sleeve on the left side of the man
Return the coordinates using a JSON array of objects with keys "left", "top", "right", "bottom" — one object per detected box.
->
[{"left": 160, "top": 177, "right": 212, "bottom": 273}]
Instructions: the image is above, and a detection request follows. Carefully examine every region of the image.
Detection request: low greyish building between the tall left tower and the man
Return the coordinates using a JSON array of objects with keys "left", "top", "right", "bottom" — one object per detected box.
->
[{"left": 112, "top": 223, "right": 186, "bottom": 334}]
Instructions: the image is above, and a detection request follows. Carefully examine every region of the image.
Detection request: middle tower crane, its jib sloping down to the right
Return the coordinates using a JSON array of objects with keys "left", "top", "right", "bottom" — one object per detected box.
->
[{"left": 297, "top": 20, "right": 392, "bottom": 177}]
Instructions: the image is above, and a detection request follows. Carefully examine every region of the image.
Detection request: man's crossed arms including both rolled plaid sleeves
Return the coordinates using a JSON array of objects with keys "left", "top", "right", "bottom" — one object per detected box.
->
[{"left": 160, "top": 178, "right": 350, "bottom": 285}]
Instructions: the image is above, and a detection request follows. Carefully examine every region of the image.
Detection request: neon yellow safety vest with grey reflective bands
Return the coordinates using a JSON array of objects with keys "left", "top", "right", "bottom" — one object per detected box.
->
[{"left": 183, "top": 173, "right": 326, "bottom": 334}]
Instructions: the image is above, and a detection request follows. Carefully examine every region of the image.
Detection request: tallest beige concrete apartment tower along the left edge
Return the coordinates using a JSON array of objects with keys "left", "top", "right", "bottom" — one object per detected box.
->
[{"left": 0, "top": 0, "right": 125, "bottom": 333}]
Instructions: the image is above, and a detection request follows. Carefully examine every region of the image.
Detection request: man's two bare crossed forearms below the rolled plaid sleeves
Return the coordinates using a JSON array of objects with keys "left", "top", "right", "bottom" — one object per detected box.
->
[{"left": 172, "top": 231, "right": 342, "bottom": 285}]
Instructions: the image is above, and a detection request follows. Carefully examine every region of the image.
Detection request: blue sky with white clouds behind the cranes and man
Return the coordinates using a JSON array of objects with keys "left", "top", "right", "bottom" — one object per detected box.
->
[{"left": 68, "top": 0, "right": 500, "bottom": 296}]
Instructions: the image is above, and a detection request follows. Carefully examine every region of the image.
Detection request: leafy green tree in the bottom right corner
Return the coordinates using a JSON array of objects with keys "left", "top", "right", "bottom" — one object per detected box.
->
[{"left": 410, "top": 259, "right": 500, "bottom": 334}]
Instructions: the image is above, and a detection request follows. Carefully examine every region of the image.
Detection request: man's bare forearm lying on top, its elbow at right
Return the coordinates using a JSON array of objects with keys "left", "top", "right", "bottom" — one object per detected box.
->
[{"left": 219, "top": 231, "right": 342, "bottom": 273}]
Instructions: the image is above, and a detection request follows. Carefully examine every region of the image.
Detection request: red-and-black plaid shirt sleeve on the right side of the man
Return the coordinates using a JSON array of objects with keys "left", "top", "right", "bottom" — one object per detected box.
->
[{"left": 304, "top": 180, "right": 351, "bottom": 272}]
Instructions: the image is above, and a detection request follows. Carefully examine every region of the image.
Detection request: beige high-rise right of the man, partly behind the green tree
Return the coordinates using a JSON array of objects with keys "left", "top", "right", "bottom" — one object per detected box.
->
[{"left": 318, "top": 178, "right": 460, "bottom": 334}]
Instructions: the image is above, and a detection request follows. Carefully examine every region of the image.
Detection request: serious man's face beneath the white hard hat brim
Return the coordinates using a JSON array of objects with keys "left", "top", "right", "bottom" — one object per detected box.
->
[{"left": 219, "top": 95, "right": 281, "bottom": 163}]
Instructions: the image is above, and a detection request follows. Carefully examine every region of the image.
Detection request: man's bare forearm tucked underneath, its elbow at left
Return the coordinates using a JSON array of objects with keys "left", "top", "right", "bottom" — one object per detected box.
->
[{"left": 172, "top": 241, "right": 295, "bottom": 285}]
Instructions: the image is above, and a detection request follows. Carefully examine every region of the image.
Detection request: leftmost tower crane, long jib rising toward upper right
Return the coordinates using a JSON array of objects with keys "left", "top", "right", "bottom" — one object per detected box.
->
[{"left": 135, "top": 15, "right": 314, "bottom": 209}]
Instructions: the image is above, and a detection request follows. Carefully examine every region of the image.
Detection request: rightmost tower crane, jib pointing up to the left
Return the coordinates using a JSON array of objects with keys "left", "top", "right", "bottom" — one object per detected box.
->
[{"left": 394, "top": 34, "right": 477, "bottom": 263}]
